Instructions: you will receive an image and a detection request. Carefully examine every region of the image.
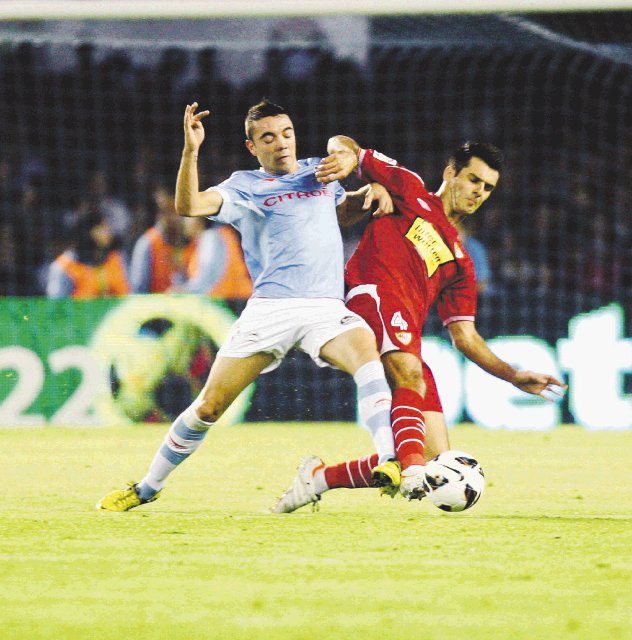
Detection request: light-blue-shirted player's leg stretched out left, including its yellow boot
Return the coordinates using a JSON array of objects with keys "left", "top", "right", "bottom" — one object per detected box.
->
[{"left": 97, "top": 353, "right": 275, "bottom": 511}]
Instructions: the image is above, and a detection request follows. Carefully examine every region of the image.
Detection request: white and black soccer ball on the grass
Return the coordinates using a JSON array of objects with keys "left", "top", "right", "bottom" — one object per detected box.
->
[{"left": 424, "top": 451, "right": 485, "bottom": 512}]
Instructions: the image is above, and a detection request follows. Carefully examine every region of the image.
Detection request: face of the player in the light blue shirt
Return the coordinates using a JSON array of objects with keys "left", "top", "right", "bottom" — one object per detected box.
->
[{"left": 246, "top": 114, "right": 298, "bottom": 175}]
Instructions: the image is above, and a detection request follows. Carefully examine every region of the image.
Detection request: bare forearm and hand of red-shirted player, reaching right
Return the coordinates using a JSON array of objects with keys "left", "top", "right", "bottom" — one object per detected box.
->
[{"left": 448, "top": 320, "right": 567, "bottom": 400}]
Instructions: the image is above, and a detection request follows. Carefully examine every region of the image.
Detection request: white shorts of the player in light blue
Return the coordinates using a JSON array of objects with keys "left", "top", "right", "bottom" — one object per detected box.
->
[{"left": 217, "top": 298, "right": 371, "bottom": 373}]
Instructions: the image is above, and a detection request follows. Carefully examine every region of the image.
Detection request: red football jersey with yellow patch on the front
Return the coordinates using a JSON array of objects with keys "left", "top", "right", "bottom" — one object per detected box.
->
[{"left": 345, "top": 150, "right": 476, "bottom": 326}]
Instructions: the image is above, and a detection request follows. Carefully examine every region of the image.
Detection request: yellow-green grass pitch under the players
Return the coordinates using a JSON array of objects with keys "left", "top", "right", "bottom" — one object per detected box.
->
[{"left": 0, "top": 424, "right": 632, "bottom": 640}]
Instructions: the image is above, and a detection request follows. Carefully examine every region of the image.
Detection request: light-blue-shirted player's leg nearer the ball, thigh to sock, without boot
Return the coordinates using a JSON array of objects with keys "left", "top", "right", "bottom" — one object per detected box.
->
[{"left": 319, "top": 326, "right": 395, "bottom": 464}]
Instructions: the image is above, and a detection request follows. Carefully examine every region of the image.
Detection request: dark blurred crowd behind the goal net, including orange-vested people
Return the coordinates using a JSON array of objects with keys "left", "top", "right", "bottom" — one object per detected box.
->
[{"left": 0, "top": 11, "right": 632, "bottom": 339}]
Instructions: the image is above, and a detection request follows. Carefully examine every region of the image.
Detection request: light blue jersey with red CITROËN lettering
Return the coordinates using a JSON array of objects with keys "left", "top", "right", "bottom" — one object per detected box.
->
[{"left": 209, "top": 158, "right": 345, "bottom": 299}]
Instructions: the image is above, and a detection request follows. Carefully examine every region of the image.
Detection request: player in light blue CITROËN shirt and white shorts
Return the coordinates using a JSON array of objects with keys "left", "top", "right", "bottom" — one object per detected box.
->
[{"left": 97, "top": 100, "right": 400, "bottom": 511}]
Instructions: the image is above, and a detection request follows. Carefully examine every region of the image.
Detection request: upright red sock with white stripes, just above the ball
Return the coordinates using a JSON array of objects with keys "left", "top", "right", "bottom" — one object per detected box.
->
[{"left": 391, "top": 388, "right": 426, "bottom": 470}]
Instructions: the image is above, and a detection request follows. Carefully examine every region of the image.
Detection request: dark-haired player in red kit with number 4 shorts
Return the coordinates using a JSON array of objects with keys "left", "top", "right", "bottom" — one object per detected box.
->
[{"left": 275, "top": 136, "right": 565, "bottom": 512}]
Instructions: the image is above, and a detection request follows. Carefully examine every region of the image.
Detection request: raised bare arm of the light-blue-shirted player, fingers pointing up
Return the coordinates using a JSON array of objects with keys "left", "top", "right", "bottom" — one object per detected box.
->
[{"left": 176, "top": 102, "right": 223, "bottom": 217}]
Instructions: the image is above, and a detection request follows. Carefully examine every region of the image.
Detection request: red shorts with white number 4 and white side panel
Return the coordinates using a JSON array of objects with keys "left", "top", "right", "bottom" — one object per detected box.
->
[{"left": 345, "top": 285, "right": 443, "bottom": 413}]
